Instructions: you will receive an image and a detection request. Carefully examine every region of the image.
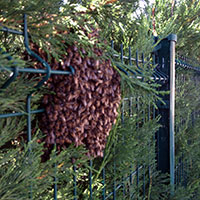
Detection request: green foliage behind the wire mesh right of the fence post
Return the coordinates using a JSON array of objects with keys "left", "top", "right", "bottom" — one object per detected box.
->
[{"left": 174, "top": 69, "right": 200, "bottom": 199}]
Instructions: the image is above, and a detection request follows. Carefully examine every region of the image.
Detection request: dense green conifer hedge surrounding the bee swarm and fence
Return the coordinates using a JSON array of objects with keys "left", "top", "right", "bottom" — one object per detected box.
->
[{"left": 0, "top": 0, "right": 200, "bottom": 200}]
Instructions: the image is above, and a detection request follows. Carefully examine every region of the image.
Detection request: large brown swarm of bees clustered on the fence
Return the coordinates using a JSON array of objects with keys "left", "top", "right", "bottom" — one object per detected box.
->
[{"left": 27, "top": 41, "right": 121, "bottom": 157}]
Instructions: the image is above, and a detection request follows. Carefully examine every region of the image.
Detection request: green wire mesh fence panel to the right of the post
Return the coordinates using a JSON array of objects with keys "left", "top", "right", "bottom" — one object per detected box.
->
[{"left": 175, "top": 55, "right": 200, "bottom": 194}]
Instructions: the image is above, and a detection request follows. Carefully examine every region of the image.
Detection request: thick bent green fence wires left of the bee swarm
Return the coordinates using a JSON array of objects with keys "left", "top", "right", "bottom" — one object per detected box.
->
[{"left": 0, "top": 14, "right": 75, "bottom": 199}]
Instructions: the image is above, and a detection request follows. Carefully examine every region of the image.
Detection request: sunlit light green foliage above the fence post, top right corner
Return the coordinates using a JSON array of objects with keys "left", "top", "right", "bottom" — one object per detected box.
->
[{"left": 147, "top": 0, "right": 200, "bottom": 59}]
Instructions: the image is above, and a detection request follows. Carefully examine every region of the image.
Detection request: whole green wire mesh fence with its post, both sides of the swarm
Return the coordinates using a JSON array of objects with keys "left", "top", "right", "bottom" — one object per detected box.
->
[{"left": 0, "top": 15, "right": 200, "bottom": 200}]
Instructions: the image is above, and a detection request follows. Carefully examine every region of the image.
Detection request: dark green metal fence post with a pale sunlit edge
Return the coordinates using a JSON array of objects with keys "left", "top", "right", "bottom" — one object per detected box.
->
[{"left": 155, "top": 34, "right": 177, "bottom": 191}]
